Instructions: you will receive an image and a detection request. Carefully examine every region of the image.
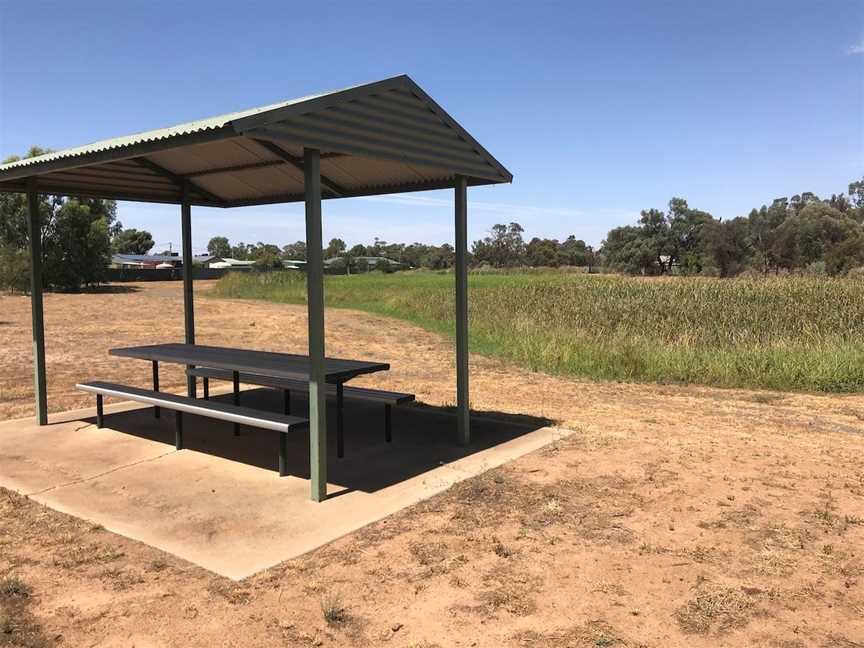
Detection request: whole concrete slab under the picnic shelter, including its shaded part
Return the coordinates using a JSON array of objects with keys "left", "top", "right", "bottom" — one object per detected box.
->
[{"left": 0, "top": 390, "right": 570, "bottom": 579}]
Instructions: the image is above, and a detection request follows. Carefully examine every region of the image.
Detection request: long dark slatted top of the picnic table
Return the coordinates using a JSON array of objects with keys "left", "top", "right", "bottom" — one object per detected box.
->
[{"left": 108, "top": 343, "right": 390, "bottom": 383}]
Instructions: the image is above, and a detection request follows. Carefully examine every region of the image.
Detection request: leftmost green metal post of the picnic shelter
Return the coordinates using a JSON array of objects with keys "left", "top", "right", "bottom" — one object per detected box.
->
[{"left": 27, "top": 180, "right": 48, "bottom": 425}]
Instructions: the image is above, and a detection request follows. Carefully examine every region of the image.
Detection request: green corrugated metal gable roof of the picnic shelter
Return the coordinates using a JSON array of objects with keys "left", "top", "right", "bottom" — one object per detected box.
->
[{"left": 0, "top": 75, "right": 513, "bottom": 207}]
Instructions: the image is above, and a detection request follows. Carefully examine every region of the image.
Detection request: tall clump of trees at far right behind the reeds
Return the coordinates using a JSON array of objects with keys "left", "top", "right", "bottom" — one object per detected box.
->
[{"left": 601, "top": 179, "right": 864, "bottom": 277}]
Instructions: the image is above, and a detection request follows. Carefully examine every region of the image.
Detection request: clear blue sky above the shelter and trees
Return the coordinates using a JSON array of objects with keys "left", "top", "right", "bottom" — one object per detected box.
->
[{"left": 0, "top": 0, "right": 864, "bottom": 250}]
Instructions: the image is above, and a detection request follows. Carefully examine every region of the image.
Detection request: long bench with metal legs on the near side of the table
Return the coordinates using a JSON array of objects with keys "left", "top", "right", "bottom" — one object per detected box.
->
[{"left": 75, "top": 381, "right": 309, "bottom": 476}]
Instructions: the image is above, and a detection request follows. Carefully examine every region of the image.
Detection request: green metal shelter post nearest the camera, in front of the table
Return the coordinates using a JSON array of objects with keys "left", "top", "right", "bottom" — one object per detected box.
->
[{"left": 303, "top": 149, "right": 327, "bottom": 502}]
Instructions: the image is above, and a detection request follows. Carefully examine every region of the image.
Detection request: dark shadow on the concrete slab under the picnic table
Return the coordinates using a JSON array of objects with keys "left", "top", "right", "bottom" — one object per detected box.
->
[{"left": 81, "top": 389, "right": 550, "bottom": 493}]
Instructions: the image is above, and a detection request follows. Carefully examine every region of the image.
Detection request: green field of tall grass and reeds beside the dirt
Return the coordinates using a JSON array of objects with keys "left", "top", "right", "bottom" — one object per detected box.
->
[{"left": 212, "top": 272, "right": 864, "bottom": 392}]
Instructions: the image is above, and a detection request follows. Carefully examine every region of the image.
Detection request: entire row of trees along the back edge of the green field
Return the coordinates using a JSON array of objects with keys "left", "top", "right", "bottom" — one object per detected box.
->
[{"left": 199, "top": 178, "right": 864, "bottom": 277}]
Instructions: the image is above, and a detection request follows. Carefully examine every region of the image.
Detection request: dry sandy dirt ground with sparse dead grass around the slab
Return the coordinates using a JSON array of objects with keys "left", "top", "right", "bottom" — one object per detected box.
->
[{"left": 0, "top": 282, "right": 864, "bottom": 648}]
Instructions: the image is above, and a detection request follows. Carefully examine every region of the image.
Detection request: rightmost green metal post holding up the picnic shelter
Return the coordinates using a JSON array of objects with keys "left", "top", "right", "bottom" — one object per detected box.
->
[{"left": 455, "top": 176, "right": 471, "bottom": 445}]
